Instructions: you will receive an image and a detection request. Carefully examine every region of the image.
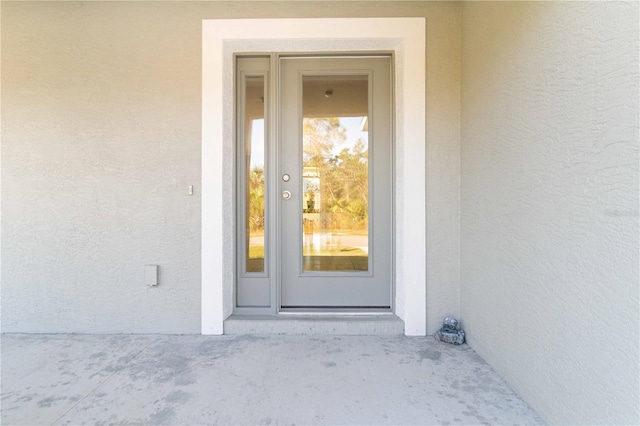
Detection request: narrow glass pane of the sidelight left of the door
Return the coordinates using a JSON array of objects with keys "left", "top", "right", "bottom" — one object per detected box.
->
[{"left": 244, "top": 76, "right": 265, "bottom": 272}]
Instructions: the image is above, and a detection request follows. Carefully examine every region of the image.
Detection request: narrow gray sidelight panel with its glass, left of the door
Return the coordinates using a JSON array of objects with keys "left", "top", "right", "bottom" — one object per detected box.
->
[{"left": 235, "top": 56, "right": 273, "bottom": 309}]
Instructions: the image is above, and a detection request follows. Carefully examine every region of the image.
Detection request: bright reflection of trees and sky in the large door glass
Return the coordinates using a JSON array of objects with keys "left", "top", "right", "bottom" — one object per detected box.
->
[{"left": 302, "top": 117, "right": 369, "bottom": 271}]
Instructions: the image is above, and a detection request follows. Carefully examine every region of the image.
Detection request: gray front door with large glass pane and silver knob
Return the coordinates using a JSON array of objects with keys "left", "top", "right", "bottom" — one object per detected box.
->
[{"left": 276, "top": 56, "right": 393, "bottom": 310}]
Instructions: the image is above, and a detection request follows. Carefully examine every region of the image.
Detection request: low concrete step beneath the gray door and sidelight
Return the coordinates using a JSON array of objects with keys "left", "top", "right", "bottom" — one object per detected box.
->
[{"left": 224, "top": 312, "right": 404, "bottom": 336}]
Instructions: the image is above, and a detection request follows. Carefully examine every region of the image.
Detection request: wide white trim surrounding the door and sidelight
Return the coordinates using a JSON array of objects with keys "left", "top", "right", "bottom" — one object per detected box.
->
[{"left": 201, "top": 18, "right": 427, "bottom": 336}]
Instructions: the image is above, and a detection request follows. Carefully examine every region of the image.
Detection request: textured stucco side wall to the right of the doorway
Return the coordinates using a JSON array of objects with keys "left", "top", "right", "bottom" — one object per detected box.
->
[{"left": 461, "top": 2, "right": 640, "bottom": 424}]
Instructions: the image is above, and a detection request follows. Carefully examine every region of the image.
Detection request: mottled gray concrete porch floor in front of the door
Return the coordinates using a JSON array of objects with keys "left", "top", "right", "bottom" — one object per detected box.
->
[{"left": 1, "top": 335, "right": 542, "bottom": 425}]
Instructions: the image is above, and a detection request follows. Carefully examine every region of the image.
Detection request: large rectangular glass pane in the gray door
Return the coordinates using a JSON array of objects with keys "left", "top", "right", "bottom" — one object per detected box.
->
[{"left": 301, "top": 75, "right": 369, "bottom": 272}]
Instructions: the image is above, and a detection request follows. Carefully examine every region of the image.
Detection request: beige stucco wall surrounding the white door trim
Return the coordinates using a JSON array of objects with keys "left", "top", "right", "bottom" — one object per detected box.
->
[{"left": 1, "top": 1, "right": 461, "bottom": 333}]
